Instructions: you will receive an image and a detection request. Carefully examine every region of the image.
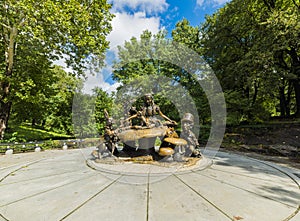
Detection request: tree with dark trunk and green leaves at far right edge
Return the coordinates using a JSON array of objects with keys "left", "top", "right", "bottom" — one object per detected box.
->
[{"left": 255, "top": 0, "right": 300, "bottom": 117}]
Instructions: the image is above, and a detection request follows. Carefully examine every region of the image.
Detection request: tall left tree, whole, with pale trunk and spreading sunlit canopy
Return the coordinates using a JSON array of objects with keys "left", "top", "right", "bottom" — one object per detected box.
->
[{"left": 0, "top": 0, "right": 112, "bottom": 138}]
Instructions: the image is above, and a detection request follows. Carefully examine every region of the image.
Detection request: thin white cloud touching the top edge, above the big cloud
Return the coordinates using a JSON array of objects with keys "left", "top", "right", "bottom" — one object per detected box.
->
[{"left": 110, "top": 0, "right": 169, "bottom": 14}]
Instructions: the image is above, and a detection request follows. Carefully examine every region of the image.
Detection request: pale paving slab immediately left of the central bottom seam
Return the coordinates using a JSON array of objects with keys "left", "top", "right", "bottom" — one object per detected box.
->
[{"left": 66, "top": 182, "right": 147, "bottom": 221}]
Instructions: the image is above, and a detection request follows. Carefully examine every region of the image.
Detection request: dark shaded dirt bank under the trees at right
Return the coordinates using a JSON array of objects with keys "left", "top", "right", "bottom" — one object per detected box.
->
[{"left": 221, "top": 123, "right": 300, "bottom": 169}]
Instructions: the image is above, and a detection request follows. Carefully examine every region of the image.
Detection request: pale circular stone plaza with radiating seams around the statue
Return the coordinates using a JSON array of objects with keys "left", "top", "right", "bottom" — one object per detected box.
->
[{"left": 0, "top": 148, "right": 300, "bottom": 221}]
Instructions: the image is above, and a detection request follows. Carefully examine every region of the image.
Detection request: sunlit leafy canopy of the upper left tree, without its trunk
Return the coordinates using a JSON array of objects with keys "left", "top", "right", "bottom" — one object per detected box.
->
[{"left": 0, "top": 0, "right": 112, "bottom": 74}]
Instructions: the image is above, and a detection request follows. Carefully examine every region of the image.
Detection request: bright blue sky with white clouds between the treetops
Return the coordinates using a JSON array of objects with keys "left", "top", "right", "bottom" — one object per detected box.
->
[{"left": 84, "top": 0, "right": 230, "bottom": 93}]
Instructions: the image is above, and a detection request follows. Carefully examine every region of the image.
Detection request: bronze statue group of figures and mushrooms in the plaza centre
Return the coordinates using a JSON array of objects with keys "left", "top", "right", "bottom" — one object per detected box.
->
[{"left": 98, "top": 94, "right": 201, "bottom": 162}]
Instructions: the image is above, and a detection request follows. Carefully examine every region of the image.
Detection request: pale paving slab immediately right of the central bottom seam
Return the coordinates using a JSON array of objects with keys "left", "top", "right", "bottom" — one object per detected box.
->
[{"left": 149, "top": 176, "right": 230, "bottom": 221}]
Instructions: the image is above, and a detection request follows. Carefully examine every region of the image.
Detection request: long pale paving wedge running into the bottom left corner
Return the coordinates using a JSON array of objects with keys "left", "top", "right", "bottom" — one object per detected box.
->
[{"left": 0, "top": 173, "right": 110, "bottom": 221}]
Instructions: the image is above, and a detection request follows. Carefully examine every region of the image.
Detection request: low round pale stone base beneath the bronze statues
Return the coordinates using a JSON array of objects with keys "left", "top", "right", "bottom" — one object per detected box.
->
[{"left": 87, "top": 156, "right": 212, "bottom": 184}]
